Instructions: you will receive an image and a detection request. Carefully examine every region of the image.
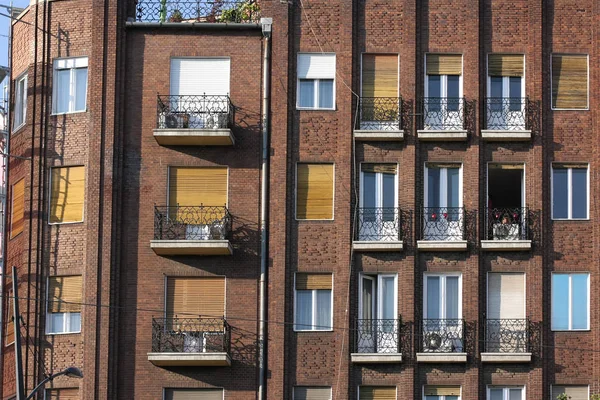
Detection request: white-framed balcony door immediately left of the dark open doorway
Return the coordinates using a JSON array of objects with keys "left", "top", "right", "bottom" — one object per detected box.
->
[{"left": 423, "top": 165, "right": 464, "bottom": 240}]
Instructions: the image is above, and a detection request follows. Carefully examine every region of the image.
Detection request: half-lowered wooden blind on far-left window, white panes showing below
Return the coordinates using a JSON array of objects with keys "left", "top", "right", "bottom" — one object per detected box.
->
[{"left": 48, "top": 275, "right": 82, "bottom": 313}]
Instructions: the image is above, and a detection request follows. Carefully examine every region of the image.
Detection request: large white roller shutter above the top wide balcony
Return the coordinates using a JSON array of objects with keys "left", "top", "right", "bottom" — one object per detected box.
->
[{"left": 171, "top": 58, "right": 230, "bottom": 96}]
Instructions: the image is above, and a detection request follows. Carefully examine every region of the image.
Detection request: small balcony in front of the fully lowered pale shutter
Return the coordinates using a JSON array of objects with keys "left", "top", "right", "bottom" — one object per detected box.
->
[{"left": 481, "top": 319, "right": 531, "bottom": 363}]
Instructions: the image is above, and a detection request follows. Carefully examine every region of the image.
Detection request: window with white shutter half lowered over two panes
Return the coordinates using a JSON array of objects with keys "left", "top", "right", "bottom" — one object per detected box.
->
[{"left": 297, "top": 53, "right": 335, "bottom": 110}]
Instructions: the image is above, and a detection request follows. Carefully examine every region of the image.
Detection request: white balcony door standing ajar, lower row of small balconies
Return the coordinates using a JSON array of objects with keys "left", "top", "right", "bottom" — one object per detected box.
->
[{"left": 357, "top": 274, "right": 399, "bottom": 353}]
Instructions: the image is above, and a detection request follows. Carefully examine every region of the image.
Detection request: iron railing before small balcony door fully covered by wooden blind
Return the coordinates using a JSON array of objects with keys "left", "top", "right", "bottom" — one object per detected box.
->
[{"left": 356, "top": 97, "right": 402, "bottom": 131}]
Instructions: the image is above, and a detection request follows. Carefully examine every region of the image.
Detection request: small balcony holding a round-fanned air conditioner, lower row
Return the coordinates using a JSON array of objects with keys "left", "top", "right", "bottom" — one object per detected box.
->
[{"left": 417, "top": 319, "right": 467, "bottom": 363}]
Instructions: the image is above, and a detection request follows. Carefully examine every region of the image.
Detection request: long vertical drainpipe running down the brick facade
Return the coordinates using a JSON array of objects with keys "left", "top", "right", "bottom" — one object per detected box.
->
[{"left": 258, "top": 18, "right": 273, "bottom": 400}]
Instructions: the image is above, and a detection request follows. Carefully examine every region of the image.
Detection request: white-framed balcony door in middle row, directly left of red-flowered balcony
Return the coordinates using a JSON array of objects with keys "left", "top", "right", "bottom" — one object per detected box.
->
[{"left": 358, "top": 164, "right": 400, "bottom": 241}]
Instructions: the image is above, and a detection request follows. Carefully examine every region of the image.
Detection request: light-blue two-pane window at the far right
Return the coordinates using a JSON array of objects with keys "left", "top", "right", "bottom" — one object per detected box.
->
[{"left": 552, "top": 273, "right": 590, "bottom": 331}]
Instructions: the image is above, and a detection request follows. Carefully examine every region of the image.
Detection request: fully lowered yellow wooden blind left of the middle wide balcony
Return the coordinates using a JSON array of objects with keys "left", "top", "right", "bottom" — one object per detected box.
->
[{"left": 50, "top": 166, "right": 85, "bottom": 223}]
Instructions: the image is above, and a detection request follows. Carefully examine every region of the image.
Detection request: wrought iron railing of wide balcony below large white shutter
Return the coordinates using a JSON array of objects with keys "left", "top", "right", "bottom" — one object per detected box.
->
[{"left": 156, "top": 94, "right": 235, "bottom": 129}]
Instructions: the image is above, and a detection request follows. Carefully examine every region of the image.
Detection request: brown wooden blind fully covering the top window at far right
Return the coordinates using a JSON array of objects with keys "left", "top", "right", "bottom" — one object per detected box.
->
[{"left": 552, "top": 54, "right": 588, "bottom": 109}]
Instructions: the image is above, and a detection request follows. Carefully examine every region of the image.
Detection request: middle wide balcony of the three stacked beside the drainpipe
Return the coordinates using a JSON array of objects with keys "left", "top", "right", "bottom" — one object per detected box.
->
[{"left": 150, "top": 205, "right": 232, "bottom": 256}]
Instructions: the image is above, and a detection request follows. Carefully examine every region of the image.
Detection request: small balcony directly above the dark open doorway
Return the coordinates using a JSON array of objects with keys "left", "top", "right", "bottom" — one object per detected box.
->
[{"left": 481, "top": 97, "right": 531, "bottom": 141}]
